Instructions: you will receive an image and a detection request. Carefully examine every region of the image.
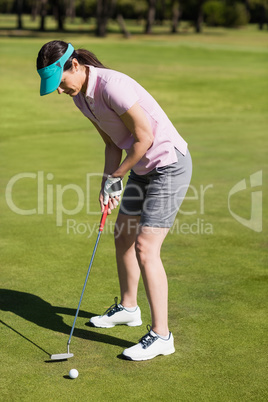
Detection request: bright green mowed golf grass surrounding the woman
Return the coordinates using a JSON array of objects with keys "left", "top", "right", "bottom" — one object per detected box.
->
[{"left": 0, "top": 23, "right": 268, "bottom": 401}]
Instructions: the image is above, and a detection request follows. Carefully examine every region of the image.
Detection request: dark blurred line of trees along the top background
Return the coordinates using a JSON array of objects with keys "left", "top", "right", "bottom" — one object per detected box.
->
[{"left": 0, "top": 0, "right": 268, "bottom": 37}]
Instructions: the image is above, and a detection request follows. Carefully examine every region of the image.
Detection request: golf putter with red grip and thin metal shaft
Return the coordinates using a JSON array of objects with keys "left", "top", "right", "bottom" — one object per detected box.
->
[{"left": 50, "top": 204, "right": 108, "bottom": 360}]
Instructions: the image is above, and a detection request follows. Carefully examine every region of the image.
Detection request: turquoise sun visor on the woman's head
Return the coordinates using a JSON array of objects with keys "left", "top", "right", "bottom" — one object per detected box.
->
[{"left": 37, "top": 43, "right": 74, "bottom": 96}]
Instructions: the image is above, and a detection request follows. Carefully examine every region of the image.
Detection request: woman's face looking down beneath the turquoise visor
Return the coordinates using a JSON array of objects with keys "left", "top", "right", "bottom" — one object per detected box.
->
[{"left": 57, "top": 59, "right": 87, "bottom": 97}]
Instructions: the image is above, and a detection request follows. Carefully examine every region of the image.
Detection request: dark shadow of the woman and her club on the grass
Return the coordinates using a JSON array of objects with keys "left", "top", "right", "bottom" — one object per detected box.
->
[{"left": 0, "top": 289, "right": 134, "bottom": 355}]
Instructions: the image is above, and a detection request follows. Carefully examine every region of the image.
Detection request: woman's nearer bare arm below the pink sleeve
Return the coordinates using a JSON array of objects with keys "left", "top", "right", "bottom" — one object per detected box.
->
[{"left": 112, "top": 103, "right": 154, "bottom": 177}]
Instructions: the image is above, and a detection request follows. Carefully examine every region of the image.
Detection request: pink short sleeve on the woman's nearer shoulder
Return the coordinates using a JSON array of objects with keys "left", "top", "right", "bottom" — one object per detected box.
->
[{"left": 103, "top": 77, "right": 139, "bottom": 116}]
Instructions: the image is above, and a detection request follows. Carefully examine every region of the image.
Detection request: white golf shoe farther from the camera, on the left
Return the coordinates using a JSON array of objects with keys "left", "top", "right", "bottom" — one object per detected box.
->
[{"left": 89, "top": 297, "right": 142, "bottom": 328}]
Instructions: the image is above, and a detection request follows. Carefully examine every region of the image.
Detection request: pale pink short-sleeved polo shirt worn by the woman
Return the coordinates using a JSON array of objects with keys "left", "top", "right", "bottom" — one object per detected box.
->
[{"left": 73, "top": 66, "right": 187, "bottom": 175}]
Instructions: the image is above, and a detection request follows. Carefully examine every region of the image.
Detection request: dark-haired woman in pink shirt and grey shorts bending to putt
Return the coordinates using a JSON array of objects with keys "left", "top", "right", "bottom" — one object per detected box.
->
[{"left": 37, "top": 41, "right": 192, "bottom": 361}]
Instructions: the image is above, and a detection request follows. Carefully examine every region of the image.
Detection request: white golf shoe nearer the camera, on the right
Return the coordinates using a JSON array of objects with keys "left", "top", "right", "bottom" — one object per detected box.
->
[{"left": 123, "top": 327, "right": 175, "bottom": 361}]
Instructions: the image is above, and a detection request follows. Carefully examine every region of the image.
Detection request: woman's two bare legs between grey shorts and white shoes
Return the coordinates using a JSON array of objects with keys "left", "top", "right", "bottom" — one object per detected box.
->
[{"left": 115, "top": 214, "right": 169, "bottom": 336}]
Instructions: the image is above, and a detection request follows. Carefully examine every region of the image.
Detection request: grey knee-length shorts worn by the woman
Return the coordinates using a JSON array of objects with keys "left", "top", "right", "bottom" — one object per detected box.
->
[{"left": 119, "top": 150, "right": 192, "bottom": 228}]
